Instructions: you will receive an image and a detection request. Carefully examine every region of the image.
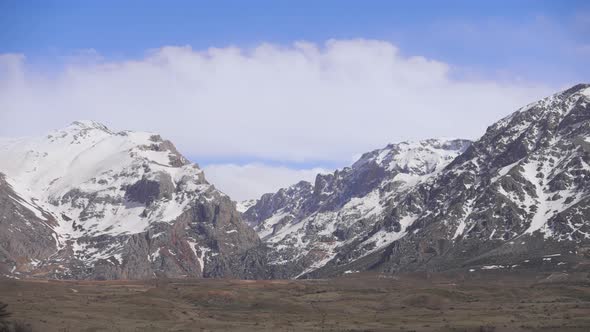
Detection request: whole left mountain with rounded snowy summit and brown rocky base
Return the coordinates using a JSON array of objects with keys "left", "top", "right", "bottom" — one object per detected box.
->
[{"left": 0, "top": 121, "right": 265, "bottom": 279}]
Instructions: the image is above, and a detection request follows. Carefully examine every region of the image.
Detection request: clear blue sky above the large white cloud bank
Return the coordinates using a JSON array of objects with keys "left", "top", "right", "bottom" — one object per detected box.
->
[{"left": 0, "top": 0, "right": 590, "bottom": 82}]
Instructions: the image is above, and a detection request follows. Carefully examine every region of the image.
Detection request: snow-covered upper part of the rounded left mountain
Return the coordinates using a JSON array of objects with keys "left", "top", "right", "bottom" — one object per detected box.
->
[{"left": 0, "top": 121, "right": 209, "bottom": 235}]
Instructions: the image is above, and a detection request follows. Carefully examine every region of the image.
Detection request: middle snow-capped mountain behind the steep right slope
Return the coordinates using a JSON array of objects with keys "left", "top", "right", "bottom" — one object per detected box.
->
[{"left": 243, "top": 139, "right": 470, "bottom": 277}]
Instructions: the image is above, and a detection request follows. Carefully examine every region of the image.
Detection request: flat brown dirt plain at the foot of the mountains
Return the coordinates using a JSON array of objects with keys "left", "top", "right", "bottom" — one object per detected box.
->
[{"left": 0, "top": 270, "right": 590, "bottom": 332}]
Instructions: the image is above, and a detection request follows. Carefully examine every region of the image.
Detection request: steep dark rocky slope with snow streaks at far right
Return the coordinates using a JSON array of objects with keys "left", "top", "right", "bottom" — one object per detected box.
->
[{"left": 310, "top": 85, "right": 590, "bottom": 276}]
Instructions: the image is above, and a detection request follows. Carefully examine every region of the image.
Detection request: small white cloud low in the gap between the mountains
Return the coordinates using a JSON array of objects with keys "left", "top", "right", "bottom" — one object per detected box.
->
[{"left": 204, "top": 163, "right": 327, "bottom": 201}]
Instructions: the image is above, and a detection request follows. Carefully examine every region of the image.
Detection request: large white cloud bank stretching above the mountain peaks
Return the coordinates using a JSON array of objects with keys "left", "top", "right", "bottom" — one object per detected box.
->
[{"left": 0, "top": 39, "right": 554, "bottom": 163}]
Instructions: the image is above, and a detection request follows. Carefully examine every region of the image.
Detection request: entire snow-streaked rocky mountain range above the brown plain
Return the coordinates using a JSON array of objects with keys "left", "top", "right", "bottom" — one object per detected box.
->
[{"left": 0, "top": 84, "right": 590, "bottom": 279}]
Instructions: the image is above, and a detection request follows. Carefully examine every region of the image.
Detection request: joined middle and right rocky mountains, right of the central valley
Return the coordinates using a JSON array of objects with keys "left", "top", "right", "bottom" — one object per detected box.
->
[{"left": 244, "top": 84, "right": 590, "bottom": 277}]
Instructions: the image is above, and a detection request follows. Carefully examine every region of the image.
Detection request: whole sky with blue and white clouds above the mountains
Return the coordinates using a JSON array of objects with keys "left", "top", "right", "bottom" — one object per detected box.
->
[{"left": 0, "top": 0, "right": 590, "bottom": 200}]
